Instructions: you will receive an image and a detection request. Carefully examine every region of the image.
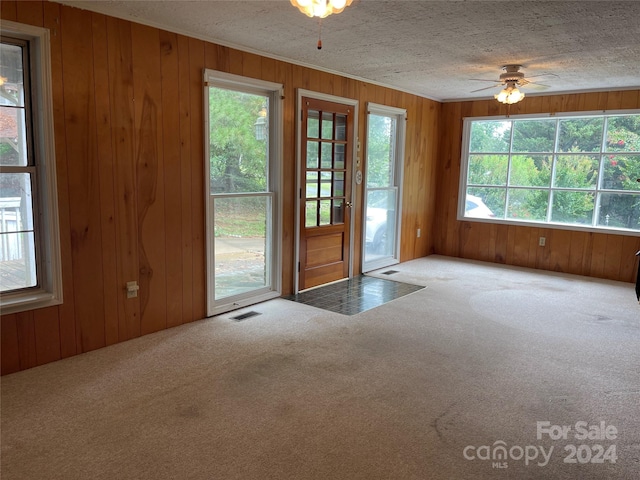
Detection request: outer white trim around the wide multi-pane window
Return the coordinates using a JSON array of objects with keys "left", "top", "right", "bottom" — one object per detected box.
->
[{"left": 457, "top": 109, "right": 640, "bottom": 237}]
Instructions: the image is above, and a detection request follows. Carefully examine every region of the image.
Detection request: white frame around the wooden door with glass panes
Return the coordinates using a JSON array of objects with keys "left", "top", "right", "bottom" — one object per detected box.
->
[{"left": 293, "top": 88, "right": 361, "bottom": 293}]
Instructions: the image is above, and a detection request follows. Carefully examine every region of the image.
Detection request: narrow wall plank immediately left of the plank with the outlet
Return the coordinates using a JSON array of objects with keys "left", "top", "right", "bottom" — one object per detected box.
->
[{"left": 92, "top": 13, "right": 121, "bottom": 345}]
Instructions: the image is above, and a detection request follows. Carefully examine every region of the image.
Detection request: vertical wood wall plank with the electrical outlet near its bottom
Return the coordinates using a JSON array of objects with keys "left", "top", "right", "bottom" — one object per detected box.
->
[{"left": 107, "top": 17, "right": 140, "bottom": 341}]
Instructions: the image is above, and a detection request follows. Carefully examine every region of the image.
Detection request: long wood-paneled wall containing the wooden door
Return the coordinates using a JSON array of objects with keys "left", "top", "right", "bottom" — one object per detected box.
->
[{"left": 0, "top": 0, "right": 441, "bottom": 374}]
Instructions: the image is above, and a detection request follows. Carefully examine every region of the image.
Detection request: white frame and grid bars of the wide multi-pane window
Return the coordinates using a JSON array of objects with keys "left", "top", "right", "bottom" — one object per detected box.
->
[{"left": 457, "top": 109, "right": 640, "bottom": 236}]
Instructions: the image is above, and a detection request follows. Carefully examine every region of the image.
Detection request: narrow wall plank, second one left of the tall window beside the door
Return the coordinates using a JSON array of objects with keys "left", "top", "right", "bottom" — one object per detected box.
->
[{"left": 178, "top": 35, "right": 195, "bottom": 323}]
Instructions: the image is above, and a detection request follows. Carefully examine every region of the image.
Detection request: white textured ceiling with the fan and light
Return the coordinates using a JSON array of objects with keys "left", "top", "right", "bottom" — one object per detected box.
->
[{"left": 60, "top": 0, "right": 640, "bottom": 101}]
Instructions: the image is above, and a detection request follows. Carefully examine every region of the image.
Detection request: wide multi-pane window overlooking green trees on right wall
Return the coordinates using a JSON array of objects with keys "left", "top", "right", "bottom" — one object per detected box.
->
[{"left": 459, "top": 112, "right": 640, "bottom": 232}]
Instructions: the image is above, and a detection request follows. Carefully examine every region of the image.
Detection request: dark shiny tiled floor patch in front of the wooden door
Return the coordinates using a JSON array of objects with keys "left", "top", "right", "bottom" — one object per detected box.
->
[{"left": 283, "top": 275, "right": 424, "bottom": 315}]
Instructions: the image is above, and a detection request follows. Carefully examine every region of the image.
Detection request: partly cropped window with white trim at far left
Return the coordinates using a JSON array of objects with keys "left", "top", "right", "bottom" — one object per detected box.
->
[{"left": 0, "top": 21, "right": 62, "bottom": 314}]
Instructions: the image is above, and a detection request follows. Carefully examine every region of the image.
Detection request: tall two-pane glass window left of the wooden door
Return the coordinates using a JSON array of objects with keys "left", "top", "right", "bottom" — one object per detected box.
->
[{"left": 205, "top": 70, "right": 281, "bottom": 315}]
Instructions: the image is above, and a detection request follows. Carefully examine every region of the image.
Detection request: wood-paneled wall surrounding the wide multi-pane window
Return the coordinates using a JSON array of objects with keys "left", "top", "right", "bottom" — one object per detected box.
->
[{"left": 434, "top": 90, "right": 640, "bottom": 282}]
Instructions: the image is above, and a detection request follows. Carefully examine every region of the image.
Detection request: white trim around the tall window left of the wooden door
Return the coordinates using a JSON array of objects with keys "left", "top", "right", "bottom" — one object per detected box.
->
[{"left": 203, "top": 69, "right": 284, "bottom": 317}]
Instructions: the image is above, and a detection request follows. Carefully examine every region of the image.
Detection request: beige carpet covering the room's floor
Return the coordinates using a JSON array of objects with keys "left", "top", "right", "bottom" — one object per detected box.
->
[{"left": 1, "top": 256, "right": 640, "bottom": 480}]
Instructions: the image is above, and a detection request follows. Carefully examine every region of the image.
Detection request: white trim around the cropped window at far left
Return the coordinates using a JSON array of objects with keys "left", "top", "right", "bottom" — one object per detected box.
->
[{"left": 0, "top": 20, "right": 63, "bottom": 315}]
